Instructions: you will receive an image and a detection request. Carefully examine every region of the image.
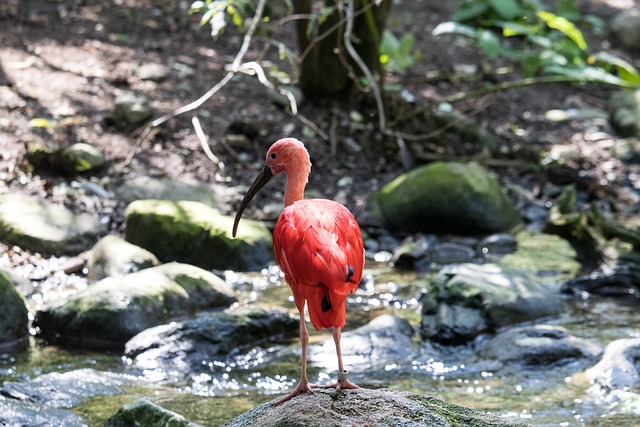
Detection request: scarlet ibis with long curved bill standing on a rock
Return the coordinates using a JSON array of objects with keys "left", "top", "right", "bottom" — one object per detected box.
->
[{"left": 233, "top": 138, "right": 364, "bottom": 405}]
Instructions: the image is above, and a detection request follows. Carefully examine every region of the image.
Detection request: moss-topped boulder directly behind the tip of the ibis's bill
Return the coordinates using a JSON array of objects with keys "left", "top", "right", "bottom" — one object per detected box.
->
[{"left": 125, "top": 200, "right": 273, "bottom": 270}]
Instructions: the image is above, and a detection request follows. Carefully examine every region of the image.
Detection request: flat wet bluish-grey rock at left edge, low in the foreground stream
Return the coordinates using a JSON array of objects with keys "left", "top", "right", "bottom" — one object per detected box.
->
[{"left": 0, "top": 369, "right": 129, "bottom": 408}]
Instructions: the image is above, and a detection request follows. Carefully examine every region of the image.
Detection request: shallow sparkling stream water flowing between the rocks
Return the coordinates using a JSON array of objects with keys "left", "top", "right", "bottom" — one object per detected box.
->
[{"left": 0, "top": 256, "right": 640, "bottom": 426}]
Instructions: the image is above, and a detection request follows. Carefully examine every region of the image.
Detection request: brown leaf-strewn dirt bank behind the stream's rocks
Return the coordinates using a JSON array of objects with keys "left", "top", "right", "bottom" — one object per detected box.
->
[{"left": 0, "top": 0, "right": 640, "bottom": 234}]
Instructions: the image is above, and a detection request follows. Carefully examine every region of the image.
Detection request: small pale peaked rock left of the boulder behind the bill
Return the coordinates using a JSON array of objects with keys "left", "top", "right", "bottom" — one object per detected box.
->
[{"left": 87, "top": 235, "right": 160, "bottom": 282}]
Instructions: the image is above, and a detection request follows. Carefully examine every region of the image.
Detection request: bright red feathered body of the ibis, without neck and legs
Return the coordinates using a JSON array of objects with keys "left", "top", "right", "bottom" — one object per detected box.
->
[{"left": 273, "top": 199, "right": 364, "bottom": 328}]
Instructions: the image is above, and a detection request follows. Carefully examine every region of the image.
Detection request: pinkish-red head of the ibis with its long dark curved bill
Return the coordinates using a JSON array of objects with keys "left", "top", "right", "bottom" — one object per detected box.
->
[{"left": 232, "top": 138, "right": 311, "bottom": 237}]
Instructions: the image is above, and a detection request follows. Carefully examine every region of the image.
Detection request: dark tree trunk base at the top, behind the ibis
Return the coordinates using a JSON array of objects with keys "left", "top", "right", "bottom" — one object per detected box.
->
[{"left": 294, "top": 0, "right": 391, "bottom": 98}]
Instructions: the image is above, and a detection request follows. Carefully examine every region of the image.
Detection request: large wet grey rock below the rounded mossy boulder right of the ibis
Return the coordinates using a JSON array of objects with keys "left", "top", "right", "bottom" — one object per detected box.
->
[{"left": 421, "top": 264, "right": 562, "bottom": 343}]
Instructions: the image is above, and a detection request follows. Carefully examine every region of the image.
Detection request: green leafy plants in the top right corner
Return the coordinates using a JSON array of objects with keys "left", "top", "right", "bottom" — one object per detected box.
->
[{"left": 434, "top": 0, "right": 640, "bottom": 88}]
